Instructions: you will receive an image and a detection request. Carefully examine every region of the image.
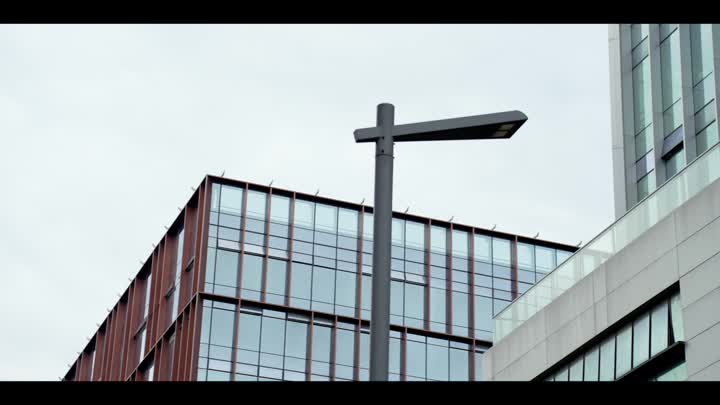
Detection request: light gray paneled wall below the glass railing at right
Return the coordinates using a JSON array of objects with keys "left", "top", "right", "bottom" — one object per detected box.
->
[{"left": 482, "top": 176, "right": 720, "bottom": 381}]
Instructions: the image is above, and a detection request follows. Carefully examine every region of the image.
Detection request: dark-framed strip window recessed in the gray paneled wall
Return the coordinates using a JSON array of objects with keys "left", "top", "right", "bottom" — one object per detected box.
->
[{"left": 546, "top": 293, "right": 687, "bottom": 381}]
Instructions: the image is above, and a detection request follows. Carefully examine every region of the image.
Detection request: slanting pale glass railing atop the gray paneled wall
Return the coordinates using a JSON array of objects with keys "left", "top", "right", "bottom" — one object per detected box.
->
[{"left": 493, "top": 144, "right": 720, "bottom": 343}]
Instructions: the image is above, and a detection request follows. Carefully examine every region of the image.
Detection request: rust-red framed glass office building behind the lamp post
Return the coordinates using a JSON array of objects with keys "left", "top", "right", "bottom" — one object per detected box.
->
[{"left": 65, "top": 176, "right": 576, "bottom": 381}]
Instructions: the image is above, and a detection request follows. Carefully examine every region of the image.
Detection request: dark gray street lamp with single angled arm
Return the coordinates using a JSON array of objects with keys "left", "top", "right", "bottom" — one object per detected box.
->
[{"left": 355, "top": 103, "right": 527, "bottom": 381}]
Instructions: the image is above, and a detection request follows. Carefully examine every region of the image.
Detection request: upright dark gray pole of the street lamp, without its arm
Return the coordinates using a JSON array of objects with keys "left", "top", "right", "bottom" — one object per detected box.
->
[{"left": 370, "top": 103, "right": 395, "bottom": 381}]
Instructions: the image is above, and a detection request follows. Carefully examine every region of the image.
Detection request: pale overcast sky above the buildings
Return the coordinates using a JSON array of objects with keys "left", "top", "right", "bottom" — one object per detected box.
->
[{"left": 0, "top": 25, "right": 613, "bottom": 380}]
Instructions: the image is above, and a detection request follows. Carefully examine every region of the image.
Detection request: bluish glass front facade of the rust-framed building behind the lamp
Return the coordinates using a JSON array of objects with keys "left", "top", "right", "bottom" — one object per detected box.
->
[{"left": 198, "top": 184, "right": 572, "bottom": 381}]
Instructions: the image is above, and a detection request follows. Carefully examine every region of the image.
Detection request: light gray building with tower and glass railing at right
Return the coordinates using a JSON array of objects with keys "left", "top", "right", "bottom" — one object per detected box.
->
[{"left": 483, "top": 24, "right": 720, "bottom": 381}]
